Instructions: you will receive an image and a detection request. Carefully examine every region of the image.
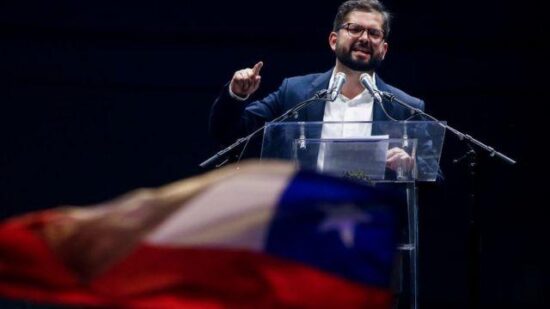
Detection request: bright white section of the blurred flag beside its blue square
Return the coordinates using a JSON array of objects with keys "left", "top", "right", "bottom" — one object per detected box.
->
[{"left": 145, "top": 168, "right": 294, "bottom": 251}]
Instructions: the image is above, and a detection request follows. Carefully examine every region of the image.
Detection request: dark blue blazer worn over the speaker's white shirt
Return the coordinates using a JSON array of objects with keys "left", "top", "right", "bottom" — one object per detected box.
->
[{"left": 210, "top": 69, "right": 424, "bottom": 144}]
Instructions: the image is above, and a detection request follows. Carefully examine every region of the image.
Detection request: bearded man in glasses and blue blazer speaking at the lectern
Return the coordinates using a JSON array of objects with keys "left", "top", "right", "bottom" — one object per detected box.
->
[{"left": 210, "top": 0, "right": 424, "bottom": 170}]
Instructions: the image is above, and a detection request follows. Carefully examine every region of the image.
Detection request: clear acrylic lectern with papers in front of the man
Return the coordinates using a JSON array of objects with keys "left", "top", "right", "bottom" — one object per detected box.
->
[{"left": 261, "top": 121, "right": 445, "bottom": 308}]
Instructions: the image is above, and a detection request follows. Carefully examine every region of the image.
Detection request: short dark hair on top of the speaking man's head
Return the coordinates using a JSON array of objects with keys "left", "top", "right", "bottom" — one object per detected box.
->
[{"left": 332, "top": 0, "right": 391, "bottom": 38}]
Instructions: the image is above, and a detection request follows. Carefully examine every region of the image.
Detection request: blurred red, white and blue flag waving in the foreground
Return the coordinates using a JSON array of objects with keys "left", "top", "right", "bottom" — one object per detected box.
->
[{"left": 0, "top": 162, "right": 399, "bottom": 308}]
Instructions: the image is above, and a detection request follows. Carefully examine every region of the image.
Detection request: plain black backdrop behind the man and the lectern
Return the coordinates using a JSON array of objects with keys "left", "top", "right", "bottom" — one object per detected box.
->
[{"left": 0, "top": 0, "right": 549, "bottom": 308}]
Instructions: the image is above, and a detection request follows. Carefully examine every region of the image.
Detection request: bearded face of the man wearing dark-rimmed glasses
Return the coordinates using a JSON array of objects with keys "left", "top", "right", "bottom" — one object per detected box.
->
[{"left": 329, "top": 11, "right": 388, "bottom": 72}]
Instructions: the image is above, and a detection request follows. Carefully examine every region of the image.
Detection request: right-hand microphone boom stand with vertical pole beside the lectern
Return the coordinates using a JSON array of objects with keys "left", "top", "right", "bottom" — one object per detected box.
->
[{"left": 375, "top": 90, "right": 516, "bottom": 308}]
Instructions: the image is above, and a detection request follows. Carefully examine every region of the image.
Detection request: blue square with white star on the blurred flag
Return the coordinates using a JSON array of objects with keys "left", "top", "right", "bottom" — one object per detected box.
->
[{"left": 266, "top": 172, "right": 404, "bottom": 288}]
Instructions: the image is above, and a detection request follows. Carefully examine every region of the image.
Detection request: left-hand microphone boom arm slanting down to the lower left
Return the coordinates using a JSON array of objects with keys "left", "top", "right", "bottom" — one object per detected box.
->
[{"left": 203, "top": 89, "right": 336, "bottom": 168}]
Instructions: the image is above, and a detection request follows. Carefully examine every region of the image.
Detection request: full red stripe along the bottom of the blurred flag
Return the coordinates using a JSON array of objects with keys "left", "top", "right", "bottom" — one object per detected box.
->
[{"left": 0, "top": 221, "right": 391, "bottom": 308}]
